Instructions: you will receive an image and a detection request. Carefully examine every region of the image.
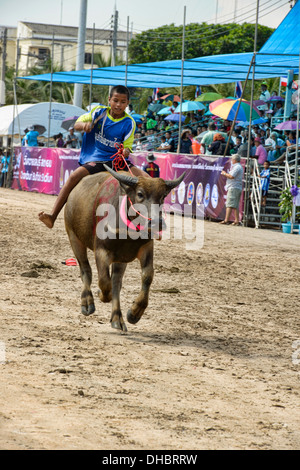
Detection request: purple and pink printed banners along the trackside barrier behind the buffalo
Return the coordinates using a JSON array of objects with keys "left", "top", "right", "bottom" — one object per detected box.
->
[{"left": 12, "top": 147, "right": 245, "bottom": 219}]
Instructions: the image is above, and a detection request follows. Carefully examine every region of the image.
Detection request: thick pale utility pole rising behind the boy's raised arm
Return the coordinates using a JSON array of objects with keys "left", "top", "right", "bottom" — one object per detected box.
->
[{"left": 73, "top": 0, "right": 87, "bottom": 108}]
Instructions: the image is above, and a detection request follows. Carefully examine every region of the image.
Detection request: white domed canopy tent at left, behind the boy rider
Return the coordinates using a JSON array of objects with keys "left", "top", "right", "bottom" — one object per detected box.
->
[{"left": 0, "top": 102, "right": 86, "bottom": 138}]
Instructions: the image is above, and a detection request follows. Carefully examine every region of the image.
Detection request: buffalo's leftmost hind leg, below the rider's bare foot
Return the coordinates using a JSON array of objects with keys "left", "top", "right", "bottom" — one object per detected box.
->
[{"left": 68, "top": 231, "right": 95, "bottom": 316}]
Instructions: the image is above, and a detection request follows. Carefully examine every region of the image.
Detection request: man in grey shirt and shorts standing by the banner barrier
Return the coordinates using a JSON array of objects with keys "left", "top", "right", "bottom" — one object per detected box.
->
[{"left": 220, "top": 154, "right": 244, "bottom": 225}]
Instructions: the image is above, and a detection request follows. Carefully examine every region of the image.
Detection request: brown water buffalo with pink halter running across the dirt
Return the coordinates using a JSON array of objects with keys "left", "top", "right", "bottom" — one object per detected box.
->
[{"left": 65, "top": 167, "right": 184, "bottom": 331}]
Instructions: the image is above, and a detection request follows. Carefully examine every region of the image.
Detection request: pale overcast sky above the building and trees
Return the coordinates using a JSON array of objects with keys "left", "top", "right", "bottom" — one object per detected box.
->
[{"left": 0, "top": 0, "right": 289, "bottom": 32}]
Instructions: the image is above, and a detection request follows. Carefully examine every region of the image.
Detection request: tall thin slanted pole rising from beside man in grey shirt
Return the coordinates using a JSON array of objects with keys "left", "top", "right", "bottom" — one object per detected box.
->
[{"left": 244, "top": 0, "right": 259, "bottom": 227}]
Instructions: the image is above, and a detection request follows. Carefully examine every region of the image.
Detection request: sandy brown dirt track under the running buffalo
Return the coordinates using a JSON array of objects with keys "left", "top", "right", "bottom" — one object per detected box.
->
[{"left": 0, "top": 185, "right": 300, "bottom": 450}]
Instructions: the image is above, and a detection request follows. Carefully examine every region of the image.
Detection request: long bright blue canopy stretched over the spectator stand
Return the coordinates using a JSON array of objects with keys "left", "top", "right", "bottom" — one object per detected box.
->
[{"left": 19, "top": 2, "right": 300, "bottom": 88}]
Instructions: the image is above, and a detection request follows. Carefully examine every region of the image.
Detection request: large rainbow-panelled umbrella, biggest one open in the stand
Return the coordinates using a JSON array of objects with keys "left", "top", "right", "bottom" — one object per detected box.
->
[{"left": 209, "top": 98, "right": 260, "bottom": 121}]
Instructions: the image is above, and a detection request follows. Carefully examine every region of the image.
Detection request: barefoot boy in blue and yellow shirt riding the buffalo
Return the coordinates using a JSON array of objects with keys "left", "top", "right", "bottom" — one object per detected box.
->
[{"left": 39, "top": 85, "right": 145, "bottom": 228}]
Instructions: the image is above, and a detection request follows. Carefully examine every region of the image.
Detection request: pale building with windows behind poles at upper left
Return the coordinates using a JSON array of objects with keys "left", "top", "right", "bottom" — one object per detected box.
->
[{"left": 0, "top": 21, "right": 127, "bottom": 76}]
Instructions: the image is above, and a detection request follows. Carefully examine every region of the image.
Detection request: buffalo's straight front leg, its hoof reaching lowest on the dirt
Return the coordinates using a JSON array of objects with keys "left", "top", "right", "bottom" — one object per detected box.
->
[{"left": 110, "top": 263, "right": 127, "bottom": 332}]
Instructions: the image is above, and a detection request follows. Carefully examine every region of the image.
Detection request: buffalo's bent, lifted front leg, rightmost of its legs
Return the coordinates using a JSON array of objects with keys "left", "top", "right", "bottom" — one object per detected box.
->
[{"left": 127, "top": 240, "right": 154, "bottom": 324}]
